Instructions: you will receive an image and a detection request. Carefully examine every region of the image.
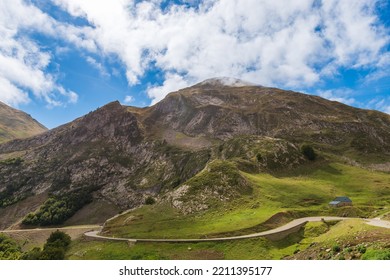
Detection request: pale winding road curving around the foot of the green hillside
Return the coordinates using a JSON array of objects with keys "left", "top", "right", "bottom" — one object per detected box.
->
[{"left": 84, "top": 216, "right": 390, "bottom": 242}]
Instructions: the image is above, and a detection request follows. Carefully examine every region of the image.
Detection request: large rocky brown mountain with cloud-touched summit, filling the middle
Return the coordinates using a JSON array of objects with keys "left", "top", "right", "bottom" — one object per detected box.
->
[{"left": 0, "top": 78, "right": 390, "bottom": 228}]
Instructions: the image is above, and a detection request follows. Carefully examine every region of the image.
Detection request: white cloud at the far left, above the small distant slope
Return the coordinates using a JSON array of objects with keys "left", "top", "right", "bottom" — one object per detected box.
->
[{"left": 0, "top": 0, "right": 93, "bottom": 106}]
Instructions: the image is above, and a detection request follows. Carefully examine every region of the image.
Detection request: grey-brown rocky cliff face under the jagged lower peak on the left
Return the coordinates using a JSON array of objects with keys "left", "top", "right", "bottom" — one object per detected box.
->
[{"left": 0, "top": 102, "right": 208, "bottom": 228}]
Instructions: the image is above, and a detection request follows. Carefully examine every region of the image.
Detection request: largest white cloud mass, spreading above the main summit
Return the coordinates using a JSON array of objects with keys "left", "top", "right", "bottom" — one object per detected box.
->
[{"left": 50, "top": 0, "right": 389, "bottom": 102}]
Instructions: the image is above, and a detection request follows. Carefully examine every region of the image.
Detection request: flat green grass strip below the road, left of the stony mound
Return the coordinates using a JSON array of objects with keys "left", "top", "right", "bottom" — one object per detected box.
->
[{"left": 67, "top": 233, "right": 301, "bottom": 260}]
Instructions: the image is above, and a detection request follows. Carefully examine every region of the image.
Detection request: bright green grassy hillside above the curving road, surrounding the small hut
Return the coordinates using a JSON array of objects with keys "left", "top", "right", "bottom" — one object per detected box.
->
[{"left": 104, "top": 163, "right": 390, "bottom": 238}]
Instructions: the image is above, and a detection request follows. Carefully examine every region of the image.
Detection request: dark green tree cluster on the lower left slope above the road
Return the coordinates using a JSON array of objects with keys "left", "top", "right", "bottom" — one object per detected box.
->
[{"left": 22, "top": 190, "right": 92, "bottom": 226}]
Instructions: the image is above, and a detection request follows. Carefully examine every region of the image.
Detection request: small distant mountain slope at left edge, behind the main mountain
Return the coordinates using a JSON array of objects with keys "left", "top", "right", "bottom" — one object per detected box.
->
[{"left": 0, "top": 102, "right": 47, "bottom": 143}]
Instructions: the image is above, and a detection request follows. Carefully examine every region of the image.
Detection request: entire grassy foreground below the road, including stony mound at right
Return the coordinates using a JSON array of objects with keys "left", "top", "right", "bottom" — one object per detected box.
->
[{"left": 67, "top": 220, "right": 390, "bottom": 260}]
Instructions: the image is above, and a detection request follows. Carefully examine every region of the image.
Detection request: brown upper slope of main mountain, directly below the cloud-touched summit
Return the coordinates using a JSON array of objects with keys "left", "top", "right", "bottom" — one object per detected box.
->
[{"left": 145, "top": 83, "right": 390, "bottom": 159}]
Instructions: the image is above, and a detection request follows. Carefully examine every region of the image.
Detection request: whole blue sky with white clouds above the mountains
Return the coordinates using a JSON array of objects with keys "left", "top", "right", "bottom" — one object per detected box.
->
[{"left": 0, "top": 0, "right": 390, "bottom": 128}]
